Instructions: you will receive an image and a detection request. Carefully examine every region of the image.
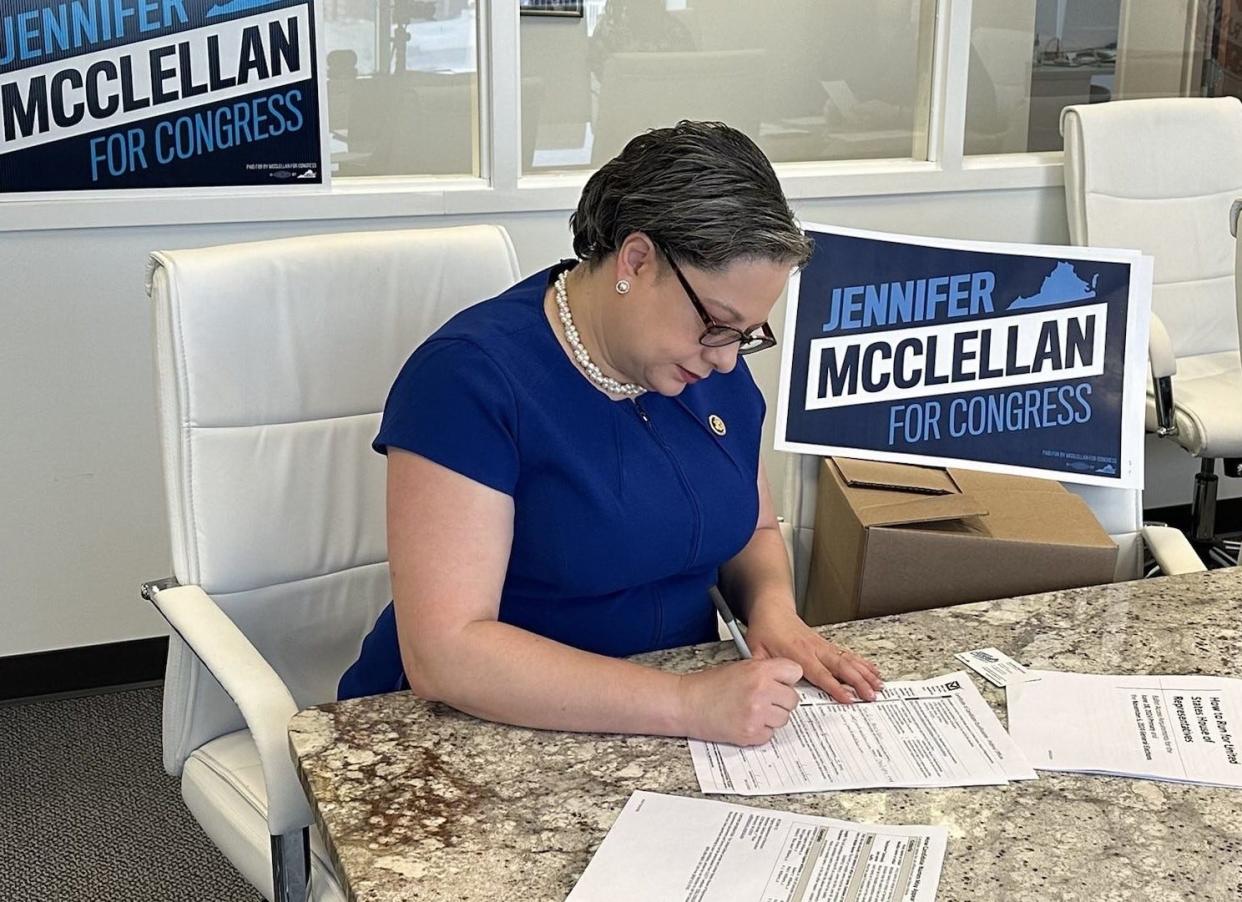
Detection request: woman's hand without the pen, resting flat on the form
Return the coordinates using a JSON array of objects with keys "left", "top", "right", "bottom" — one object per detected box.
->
[{"left": 746, "top": 600, "right": 884, "bottom": 703}]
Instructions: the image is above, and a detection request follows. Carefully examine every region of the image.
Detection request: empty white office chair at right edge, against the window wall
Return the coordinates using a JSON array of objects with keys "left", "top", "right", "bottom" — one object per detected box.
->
[{"left": 1061, "top": 97, "right": 1242, "bottom": 565}]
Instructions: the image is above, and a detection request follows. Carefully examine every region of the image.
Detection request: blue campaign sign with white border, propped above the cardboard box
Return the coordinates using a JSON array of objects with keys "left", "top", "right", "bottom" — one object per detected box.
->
[{"left": 776, "top": 225, "right": 1151, "bottom": 488}]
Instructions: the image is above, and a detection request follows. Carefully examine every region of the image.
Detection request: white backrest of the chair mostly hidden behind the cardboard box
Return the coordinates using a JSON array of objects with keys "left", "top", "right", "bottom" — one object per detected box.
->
[{"left": 782, "top": 453, "right": 1143, "bottom": 610}]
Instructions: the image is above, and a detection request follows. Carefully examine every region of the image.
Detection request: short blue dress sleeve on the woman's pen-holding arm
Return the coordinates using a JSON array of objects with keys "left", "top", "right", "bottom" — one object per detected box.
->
[{"left": 371, "top": 338, "right": 518, "bottom": 496}]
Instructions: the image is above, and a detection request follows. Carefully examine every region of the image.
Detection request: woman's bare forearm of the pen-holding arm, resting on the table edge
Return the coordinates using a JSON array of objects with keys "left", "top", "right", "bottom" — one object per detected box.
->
[{"left": 404, "top": 620, "right": 689, "bottom": 736}]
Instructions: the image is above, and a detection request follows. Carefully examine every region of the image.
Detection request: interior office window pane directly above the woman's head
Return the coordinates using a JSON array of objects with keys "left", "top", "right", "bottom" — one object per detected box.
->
[{"left": 520, "top": 0, "right": 935, "bottom": 173}]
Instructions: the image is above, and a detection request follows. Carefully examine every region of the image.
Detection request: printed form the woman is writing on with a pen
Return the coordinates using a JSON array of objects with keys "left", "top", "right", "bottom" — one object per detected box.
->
[{"left": 689, "top": 671, "right": 1035, "bottom": 795}]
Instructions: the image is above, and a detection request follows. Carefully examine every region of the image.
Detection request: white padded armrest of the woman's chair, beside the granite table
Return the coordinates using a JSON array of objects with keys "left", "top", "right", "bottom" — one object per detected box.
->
[{"left": 149, "top": 585, "right": 311, "bottom": 836}]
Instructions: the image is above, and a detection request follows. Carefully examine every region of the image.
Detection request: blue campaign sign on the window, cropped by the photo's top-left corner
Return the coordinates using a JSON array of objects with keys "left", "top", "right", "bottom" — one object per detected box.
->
[{"left": 0, "top": 0, "right": 327, "bottom": 195}]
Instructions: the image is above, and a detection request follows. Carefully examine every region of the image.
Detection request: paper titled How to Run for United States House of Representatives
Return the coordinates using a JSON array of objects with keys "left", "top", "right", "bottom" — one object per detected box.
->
[{"left": 1006, "top": 671, "right": 1242, "bottom": 788}]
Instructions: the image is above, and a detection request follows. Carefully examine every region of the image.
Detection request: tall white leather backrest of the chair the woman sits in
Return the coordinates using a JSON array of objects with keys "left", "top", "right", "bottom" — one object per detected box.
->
[{"left": 148, "top": 226, "right": 518, "bottom": 773}]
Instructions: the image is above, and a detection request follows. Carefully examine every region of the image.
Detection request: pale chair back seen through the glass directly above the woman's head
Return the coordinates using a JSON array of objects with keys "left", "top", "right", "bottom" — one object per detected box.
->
[{"left": 591, "top": 50, "right": 764, "bottom": 165}]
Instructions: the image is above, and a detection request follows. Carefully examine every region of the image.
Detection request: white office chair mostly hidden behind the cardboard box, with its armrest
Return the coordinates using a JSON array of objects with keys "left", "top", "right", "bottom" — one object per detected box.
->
[{"left": 781, "top": 453, "right": 1205, "bottom": 610}]
